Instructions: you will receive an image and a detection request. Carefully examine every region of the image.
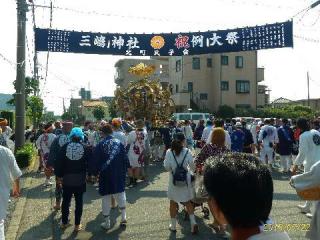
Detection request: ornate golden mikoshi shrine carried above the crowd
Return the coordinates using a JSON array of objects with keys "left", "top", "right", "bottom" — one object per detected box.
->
[{"left": 115, "top": 63, "right": 174, "bottom": 125}]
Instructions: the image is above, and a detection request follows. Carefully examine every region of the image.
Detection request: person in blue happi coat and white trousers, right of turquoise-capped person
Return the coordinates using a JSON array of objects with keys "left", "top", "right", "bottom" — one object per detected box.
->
[{"left": 94, "top": 124, "right": 129, "bottom": 230}]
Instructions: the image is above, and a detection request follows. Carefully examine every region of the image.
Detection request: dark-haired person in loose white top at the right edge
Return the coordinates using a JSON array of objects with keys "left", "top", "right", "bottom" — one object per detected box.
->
[{"left": 293, "top": 118, "right": 320, "bottom": 217}]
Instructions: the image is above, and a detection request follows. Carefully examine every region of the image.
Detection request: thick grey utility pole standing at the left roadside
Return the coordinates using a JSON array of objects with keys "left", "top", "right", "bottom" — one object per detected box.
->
[{"left": 15, "top": 0, "right": 28, "bottom": 150}]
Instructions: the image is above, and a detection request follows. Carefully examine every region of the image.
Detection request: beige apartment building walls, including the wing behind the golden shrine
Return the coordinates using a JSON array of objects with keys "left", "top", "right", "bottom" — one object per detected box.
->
[{"left": 115, "top": 51, "right": 266, "bottom": 112}]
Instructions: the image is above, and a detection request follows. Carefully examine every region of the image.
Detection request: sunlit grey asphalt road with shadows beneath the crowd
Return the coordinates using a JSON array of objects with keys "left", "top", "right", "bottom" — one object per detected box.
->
[{"left": 12, "top": 158, "right": 310, "bottom": 240}]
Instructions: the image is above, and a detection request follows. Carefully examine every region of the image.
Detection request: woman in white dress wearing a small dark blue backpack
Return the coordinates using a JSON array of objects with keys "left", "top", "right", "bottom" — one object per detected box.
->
[{"left": 163, "top": 133, "right": 198, "bottom": 234}]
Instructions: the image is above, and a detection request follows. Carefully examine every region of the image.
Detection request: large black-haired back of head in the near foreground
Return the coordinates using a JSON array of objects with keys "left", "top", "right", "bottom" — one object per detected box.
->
[{"left": 204, "top": 153, "right": 273, "bottom": 229}]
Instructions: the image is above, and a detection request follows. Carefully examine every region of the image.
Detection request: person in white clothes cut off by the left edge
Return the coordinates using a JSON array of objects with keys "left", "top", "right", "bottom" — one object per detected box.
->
[{"left": 0, "top": 146, "right": 22, "bottom": 240}]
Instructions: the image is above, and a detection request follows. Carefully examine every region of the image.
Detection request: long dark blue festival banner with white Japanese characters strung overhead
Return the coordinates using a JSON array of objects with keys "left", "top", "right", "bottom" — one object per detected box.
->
[{"left": 35, "top": 21, "right": 293, "bottom": 56}]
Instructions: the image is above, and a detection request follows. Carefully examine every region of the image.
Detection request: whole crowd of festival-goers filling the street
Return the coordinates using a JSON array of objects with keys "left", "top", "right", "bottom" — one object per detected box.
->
[{"left": 0, "top": 115, "right": 320, "bottom": 240}]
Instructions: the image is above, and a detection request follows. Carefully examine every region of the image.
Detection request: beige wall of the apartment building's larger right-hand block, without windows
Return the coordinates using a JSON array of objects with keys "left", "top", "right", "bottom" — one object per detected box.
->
[{"left": 169, "top": 51, "right": 264, "bottom": 111}]
